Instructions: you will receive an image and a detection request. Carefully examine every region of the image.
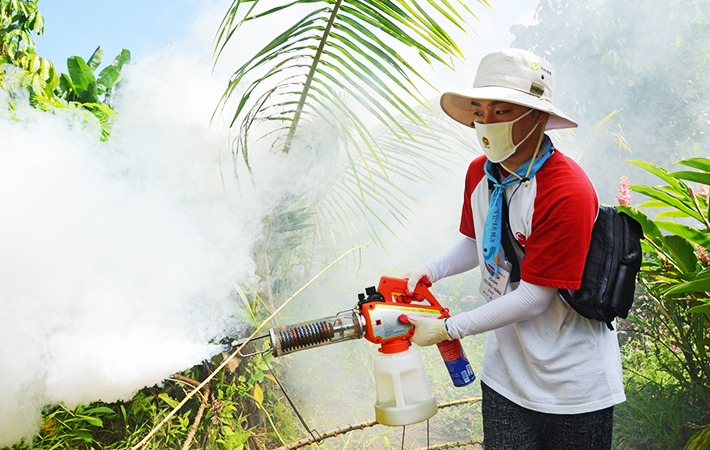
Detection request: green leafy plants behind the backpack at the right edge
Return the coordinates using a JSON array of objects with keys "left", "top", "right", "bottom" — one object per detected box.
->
[{"left": 619, "top": 158, "right": 710, "bottom": 448}]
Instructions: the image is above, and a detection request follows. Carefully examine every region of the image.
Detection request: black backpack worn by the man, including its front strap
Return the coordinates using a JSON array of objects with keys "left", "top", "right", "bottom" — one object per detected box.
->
[{"left": 501, "top": 204, "right": 643, "bottom": 330}]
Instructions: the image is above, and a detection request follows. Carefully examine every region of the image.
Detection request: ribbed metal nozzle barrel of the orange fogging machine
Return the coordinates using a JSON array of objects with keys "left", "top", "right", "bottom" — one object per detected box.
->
[{"left": 269, "top": 309, "right": 365, "bottom": 356}]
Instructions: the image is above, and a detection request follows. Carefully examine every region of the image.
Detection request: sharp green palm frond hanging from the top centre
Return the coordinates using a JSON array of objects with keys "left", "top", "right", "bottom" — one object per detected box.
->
[{"left": 215, "top": 0, "right": 488, "bottom": 174}]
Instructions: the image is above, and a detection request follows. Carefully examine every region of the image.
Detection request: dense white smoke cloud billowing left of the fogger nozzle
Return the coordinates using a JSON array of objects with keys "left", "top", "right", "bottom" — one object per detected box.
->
[{"left": 0, "top": 4, "right": 342, "bottom": 447}]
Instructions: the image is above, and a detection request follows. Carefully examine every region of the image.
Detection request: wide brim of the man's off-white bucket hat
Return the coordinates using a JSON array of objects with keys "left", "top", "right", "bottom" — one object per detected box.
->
[{"left": 440, "top": 86, "right": 578, "bottom": 130}]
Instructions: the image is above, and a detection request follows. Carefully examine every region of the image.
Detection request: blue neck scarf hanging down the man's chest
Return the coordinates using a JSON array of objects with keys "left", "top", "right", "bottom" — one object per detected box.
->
[{"left": 483, "top": 137, "right": 554, "bottom": 278}]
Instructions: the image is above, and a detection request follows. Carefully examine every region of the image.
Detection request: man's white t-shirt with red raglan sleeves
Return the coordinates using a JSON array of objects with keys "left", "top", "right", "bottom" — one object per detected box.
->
[{"left": 449, "top": 145, "right": 625, "bottom": 414}]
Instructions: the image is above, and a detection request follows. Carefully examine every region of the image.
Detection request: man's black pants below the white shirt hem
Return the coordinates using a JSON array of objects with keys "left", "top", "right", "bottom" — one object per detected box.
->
[{"left": 481, "top": 382, "right": 614, "bottom": 450}]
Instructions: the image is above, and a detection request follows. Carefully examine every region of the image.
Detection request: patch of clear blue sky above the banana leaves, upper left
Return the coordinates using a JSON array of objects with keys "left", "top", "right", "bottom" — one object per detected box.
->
[{"left": 35, "top": 0, "right": 207, "bottom": 72}]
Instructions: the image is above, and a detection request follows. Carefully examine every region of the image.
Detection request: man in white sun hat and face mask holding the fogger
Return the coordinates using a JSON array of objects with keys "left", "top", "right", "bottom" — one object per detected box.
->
[{"left": 405, "top": 49, "right": 625, "bottom": 450}]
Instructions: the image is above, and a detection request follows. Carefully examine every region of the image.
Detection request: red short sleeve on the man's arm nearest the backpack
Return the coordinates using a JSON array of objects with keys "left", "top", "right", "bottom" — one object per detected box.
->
[{"left": 521, "top": 152, "right": 599, "bottom": 289}]
